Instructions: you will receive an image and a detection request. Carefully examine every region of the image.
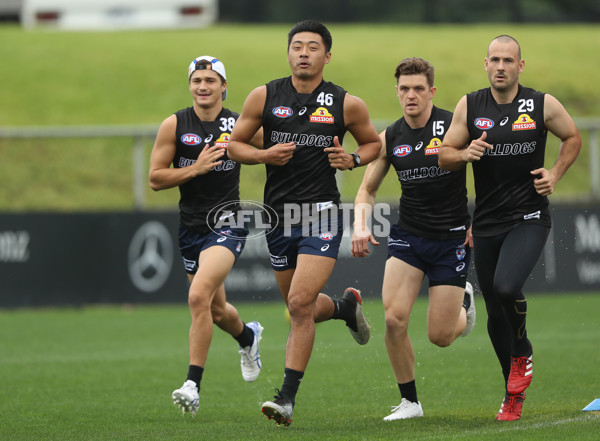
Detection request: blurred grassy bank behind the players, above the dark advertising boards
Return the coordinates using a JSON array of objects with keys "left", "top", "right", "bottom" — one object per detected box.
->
[{"left": 0, "top": 23, "right": 600, "bottom": 211}]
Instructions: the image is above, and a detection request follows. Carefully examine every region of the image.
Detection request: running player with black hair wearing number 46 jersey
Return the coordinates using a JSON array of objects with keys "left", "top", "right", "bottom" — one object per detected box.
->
[{"left": 229, "top": 20, "right": 381, "bottom": 425}]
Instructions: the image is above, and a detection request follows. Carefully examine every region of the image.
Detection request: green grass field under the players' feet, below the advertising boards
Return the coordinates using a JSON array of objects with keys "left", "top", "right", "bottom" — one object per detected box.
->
[{"left": 0, "top": 293, "right": 600, "bottom": 441}]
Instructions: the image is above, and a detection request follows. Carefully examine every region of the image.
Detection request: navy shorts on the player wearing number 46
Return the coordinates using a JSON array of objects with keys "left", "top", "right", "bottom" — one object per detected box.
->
[{"left": 267, "top": 214, "right": 344, "bottom": 271}]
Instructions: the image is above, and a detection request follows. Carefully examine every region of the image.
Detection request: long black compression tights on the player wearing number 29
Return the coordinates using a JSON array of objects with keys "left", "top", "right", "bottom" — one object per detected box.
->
[{"left": 474, "top": 224, "right": 550, "bottom": 381}]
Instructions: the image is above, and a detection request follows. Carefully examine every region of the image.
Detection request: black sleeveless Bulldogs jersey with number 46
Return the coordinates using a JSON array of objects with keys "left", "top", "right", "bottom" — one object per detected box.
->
[{"left": 262, "top": 77, "right": 346, "bottom": 223}]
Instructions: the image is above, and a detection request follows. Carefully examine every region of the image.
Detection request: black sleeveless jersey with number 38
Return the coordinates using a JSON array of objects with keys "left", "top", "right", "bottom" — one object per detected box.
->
[{"left": 173, "top": 107, "right": 240, "bottom": 233}]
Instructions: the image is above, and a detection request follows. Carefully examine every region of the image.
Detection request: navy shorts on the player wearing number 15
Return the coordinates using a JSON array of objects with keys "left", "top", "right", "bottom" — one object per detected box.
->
[{"left": 388, "top": 225, "right": 471, "bottom": 288}]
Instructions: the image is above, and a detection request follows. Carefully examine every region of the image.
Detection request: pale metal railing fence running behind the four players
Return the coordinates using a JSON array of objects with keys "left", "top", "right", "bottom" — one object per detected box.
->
[{"left": 0, "top": 117, "right": 600, "bottom": 210}]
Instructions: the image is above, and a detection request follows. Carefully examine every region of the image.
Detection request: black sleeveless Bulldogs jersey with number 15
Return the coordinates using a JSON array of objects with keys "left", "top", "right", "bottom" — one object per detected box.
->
[{"left": 385, "top": 106, "right": 470, "bottom": 239}]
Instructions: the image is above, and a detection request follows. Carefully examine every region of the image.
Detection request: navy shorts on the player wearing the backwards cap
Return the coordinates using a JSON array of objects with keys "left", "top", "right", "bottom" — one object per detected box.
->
[{"left": 179, "top": 225, "right": 248, "bottom": 274}]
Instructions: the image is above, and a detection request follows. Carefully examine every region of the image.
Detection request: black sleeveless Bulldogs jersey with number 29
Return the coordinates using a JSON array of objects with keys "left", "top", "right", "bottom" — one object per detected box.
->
[{"left": 467, "top": 85, "right": 551, "bottom": 236}]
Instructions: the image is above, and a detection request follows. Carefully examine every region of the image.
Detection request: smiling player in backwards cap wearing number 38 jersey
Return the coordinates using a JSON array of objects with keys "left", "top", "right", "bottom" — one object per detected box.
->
[{"left": 149, "top": 56, "right": 263, "bottom": 414}]
